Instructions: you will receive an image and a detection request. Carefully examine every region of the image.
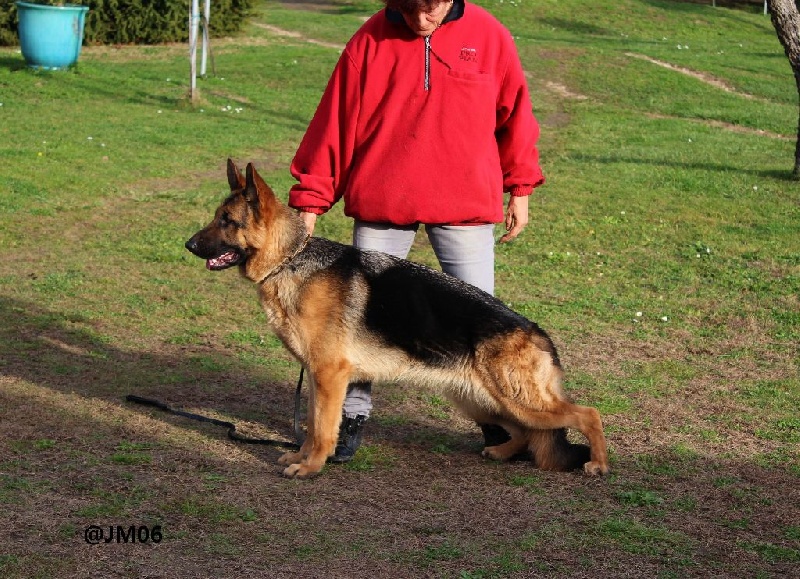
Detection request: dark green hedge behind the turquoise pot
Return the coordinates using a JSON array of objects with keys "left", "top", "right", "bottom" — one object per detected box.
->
[{"left": 0, "top": 0, "right": 253, "bottom": 46}]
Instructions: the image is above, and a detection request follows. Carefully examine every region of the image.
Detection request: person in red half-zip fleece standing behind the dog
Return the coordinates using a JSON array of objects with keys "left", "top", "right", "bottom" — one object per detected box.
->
[{"left": 289, "top": 0, "right": 544, "bottom": 462}]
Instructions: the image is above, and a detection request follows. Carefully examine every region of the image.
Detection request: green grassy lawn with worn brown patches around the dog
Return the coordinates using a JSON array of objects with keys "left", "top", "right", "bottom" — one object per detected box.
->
[{"left": 0, "top": 0, "right": 800, "bottom": 578}]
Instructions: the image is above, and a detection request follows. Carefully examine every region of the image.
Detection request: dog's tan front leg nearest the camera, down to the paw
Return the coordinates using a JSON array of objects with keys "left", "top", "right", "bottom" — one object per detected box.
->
[{"left": 281, "top": 360, "right": 350, "bottom": 478}]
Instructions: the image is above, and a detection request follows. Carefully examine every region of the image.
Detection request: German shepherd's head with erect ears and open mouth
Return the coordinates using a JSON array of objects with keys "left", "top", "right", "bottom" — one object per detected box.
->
[{"left": 186, "top": 159, "right": 277, "bottom": 271}]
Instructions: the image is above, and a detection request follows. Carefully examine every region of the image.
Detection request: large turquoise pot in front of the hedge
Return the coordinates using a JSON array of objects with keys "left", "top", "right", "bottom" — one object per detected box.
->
[{"left": 16, "top": 2, "right": 89, "bottom": 69}]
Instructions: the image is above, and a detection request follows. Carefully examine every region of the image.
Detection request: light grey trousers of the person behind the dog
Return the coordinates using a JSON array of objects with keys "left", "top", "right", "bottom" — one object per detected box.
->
[{"left": 344, "top": 221, "right": 494, "bottom": 418}]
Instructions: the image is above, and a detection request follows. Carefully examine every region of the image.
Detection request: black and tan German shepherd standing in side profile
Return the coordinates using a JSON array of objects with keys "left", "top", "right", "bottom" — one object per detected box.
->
[{"left": 186, "top": 159, "right": 609, "bottom": 478}]
